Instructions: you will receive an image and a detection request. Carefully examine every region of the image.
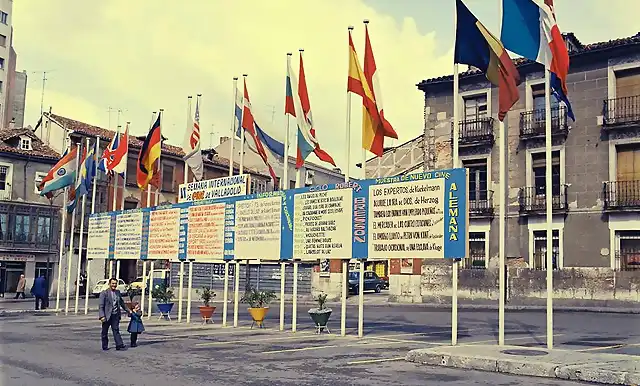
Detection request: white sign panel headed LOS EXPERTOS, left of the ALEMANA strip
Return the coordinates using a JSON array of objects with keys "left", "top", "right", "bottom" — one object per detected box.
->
[{"left": 368, "top": 178, "right": 446, "bottom": 258}]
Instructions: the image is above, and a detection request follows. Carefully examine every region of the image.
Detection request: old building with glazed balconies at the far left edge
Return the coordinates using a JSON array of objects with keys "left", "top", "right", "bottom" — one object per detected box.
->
[{"left": 0, "top": 128, "right": 62, "bottom": 292}]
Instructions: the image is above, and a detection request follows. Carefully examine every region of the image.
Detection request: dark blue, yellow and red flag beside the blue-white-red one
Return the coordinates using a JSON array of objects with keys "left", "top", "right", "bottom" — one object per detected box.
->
[{"left": 453, "top": 0, "right": 520, "bottom": 121}]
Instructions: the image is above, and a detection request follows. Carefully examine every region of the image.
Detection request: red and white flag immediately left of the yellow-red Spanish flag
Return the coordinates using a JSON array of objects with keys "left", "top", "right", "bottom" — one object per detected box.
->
[{"left": 294, "top": 52, "right": 336, "bottom": 169}]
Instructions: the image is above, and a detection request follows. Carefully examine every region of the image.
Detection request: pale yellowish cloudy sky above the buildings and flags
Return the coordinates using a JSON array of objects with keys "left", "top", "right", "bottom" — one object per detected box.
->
[{"left": 13, "top": 0, "right": 640, "bottom": 174}]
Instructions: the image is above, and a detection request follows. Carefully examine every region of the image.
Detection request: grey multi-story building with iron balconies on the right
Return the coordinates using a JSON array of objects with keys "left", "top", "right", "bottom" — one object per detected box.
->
[{"left": 418, "top": 34, "right": 640, "bottom": 270}]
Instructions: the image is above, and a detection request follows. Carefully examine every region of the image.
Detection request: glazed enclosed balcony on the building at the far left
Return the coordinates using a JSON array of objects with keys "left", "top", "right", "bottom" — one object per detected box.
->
[{"left": 0, "top": 201, "right": 60, "bottom": 253}]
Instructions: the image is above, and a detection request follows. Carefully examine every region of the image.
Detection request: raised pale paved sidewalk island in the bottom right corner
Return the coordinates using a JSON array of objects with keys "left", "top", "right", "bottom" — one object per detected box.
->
[{"left": 405, "top": 345, "right": 640, "bottom": 385}]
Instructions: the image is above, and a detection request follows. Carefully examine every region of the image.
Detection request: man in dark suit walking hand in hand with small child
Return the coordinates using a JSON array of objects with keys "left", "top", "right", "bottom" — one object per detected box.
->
[{"left": 98, "top": 278, "right": 129, "bottom": 351}]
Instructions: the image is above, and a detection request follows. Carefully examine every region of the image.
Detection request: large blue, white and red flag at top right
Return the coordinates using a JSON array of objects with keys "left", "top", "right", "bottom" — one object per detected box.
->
[{"left": 500, "top": 0, "right": 575, "bottom": 120}]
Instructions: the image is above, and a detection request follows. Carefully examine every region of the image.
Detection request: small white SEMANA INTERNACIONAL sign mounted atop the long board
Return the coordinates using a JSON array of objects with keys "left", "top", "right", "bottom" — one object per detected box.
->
[{"left": 178, "top": 174, "right": 249, "bottom": 203}]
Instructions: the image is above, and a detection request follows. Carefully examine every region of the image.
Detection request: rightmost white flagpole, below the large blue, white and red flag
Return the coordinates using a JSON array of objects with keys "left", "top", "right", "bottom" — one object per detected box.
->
[{"left": 544, "top": 68, "right": 553, "bottom": 350}]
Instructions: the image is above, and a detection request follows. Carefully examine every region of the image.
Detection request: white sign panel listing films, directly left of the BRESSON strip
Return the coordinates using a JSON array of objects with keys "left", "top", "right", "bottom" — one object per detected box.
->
[{"left": 293, "top": 189, "right": 353, "bottom": 259}]
